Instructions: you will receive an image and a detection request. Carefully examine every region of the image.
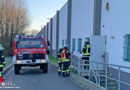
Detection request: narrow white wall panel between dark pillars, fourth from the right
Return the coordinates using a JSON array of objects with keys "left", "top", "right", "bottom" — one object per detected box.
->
[{"left": 52, "top": 15, "right": 56, "bottom": 50}]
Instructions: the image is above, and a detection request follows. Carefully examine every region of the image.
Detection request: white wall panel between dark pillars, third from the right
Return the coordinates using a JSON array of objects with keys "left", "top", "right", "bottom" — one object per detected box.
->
[{"left": 59, "top": 3, "right": 68, "bottom": 46}]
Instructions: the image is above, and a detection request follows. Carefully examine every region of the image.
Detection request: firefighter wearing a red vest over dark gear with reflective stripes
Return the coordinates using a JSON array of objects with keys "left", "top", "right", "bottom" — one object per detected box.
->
[{"left": 61, "top": 46, "right": 71, "bottom": 76}]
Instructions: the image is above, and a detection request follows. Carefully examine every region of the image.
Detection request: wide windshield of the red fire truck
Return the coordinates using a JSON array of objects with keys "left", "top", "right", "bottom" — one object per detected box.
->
[{"left": 17, "top": 39, "right": 44, "bottom": 48}]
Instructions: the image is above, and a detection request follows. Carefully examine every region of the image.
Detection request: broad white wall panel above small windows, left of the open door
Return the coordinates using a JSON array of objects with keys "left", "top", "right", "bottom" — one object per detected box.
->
[{"left": 71, "top": 0, "right": 94, "bottom": 55}]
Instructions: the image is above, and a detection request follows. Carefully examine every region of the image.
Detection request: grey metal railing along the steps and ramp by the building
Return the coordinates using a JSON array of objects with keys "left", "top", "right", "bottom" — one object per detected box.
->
[{"left": 71, "top": 56, "right": 130, "bottom": 90}]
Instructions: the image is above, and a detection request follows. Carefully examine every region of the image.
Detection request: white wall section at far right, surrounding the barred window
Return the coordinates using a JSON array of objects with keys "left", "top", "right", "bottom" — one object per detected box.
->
[{"left": 101, "top": 0, "right": 130, "bottom": 71}]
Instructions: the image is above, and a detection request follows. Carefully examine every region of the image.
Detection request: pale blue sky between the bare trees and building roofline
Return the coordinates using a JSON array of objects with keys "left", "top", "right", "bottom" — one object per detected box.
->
[{"left": 25, "top": 0, "right": 68, "bottom": 31}]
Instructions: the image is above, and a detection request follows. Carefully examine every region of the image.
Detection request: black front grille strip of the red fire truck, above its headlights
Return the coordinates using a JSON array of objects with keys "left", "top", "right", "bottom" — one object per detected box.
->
[{"left": 18, "top": 54, "right": 45, "bottom": 60}]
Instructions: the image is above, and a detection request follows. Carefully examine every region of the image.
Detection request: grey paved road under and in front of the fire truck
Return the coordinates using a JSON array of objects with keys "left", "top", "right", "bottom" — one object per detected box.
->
[{"left": 0, "top": 64, "right": 84, "bottom": 90}]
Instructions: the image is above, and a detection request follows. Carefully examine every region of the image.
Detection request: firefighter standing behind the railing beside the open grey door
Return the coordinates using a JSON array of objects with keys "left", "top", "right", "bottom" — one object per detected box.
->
[{"left": 82, "top": 38, "right": 90, "bottom": 69}]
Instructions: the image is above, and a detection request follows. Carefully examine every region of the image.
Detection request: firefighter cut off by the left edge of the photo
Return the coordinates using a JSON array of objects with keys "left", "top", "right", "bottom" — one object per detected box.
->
[{"left": 0, "top": 44, "right": 5, "bottom": 84}]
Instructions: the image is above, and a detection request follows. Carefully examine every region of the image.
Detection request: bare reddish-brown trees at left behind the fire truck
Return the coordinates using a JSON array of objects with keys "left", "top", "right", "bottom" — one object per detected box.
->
[{"left": 0, "top": 0, "right": 29, "bottom": 53}]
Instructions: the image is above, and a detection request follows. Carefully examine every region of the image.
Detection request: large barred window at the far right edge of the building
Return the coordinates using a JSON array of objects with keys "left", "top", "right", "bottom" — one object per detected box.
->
[{"left": 124, "top": 34, "right": 130, "bottom": 61}]
